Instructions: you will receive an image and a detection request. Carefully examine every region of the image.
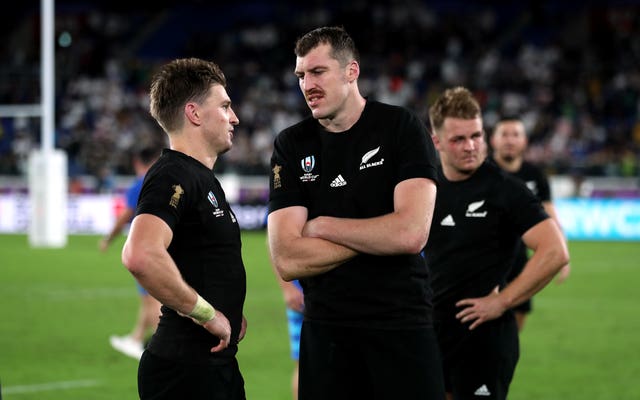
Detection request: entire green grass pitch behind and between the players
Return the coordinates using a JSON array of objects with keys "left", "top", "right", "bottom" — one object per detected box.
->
[{"left": 0, "top": 236, "right": 640, "bottom": 400}]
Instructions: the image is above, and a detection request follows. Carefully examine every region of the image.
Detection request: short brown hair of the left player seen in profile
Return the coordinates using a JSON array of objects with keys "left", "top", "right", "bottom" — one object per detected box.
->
[{"left": 149, "top": 58, "right": 227, "bottom": 133}]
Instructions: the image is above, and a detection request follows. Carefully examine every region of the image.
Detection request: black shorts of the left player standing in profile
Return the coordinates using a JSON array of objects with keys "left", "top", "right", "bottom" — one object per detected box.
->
[{"left": 138, "top": 351, "right": 246, "bottom": 400}]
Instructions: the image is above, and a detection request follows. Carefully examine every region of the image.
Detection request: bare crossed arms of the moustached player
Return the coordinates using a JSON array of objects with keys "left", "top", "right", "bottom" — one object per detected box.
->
[{"left": 267, "top": 178, "right": 436, "bottom": 281}]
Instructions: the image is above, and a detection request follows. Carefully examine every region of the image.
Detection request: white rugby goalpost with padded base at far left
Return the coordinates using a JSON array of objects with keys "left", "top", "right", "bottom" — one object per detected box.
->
[{"left": 0, "top": 0, "right": 69, "bottom": 247}]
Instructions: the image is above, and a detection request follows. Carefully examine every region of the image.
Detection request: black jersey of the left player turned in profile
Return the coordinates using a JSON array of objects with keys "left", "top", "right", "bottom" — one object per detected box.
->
[{"left": 136, "top": 149, "right": 246, "bottom": 361}]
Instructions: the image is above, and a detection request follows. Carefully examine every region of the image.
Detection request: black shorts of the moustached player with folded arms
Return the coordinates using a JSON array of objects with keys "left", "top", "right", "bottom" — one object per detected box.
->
[{"left": 298, "top": 321, "right": 445, "bottom": 400}]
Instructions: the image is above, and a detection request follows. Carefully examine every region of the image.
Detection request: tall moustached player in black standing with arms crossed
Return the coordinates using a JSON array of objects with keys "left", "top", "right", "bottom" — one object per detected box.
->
[{"left": 267, "top": 27, "right": 444, "bottom": 400}]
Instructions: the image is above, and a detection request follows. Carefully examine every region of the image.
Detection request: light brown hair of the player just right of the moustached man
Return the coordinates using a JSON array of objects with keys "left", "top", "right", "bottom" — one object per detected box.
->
[{"left": 429, "top": 86, "right": 481, "bottom": 134}]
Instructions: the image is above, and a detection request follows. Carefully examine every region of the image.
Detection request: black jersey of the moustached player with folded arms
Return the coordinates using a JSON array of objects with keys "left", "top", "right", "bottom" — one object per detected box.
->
[{"left": 269, "top": 100, "right": 437, "bottom": 328}]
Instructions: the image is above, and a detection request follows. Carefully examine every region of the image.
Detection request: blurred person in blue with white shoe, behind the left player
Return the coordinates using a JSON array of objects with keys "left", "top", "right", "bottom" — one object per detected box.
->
[{"left": 99, "top": 147, "right": 161, "bottom": 360}]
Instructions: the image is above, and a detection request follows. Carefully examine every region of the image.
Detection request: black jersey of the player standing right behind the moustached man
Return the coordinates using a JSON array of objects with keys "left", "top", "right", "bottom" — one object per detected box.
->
[{"left": 425, "top": 162, "right": 548, "bottom": 318}]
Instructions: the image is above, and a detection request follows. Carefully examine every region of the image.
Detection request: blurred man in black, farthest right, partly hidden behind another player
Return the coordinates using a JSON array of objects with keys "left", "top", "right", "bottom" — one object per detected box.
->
[{"left": 490, "top": 116, "right": 571, "bottom": 331}]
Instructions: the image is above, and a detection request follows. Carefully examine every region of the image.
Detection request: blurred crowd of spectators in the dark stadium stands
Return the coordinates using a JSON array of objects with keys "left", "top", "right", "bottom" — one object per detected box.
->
[{"left": 0, "top": 0, "right": 640, "bottom": 190}]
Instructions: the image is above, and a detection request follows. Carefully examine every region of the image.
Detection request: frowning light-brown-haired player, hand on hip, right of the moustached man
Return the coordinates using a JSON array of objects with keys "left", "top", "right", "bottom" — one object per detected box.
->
[{"left": 424, "top": 87, "right": 569, "bottom": 400}]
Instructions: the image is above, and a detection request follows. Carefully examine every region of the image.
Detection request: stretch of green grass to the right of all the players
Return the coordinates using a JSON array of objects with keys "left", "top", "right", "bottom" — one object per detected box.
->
[{"left": 510, "top": 242, "right": 640, "bottom": 400}]
